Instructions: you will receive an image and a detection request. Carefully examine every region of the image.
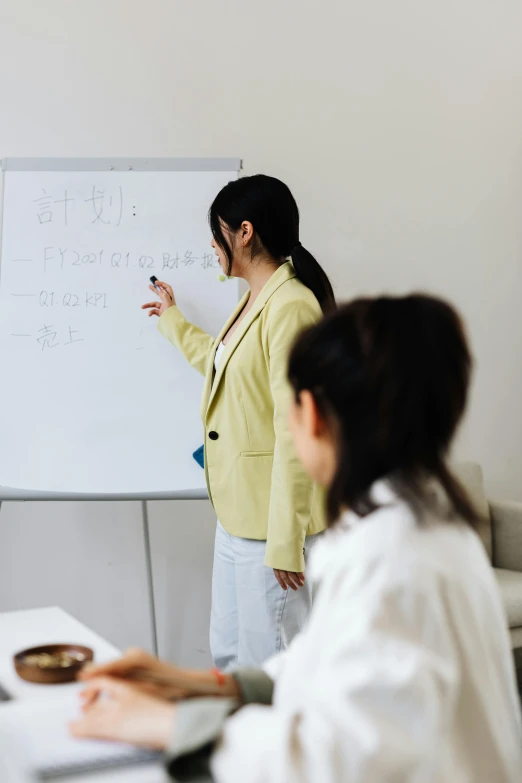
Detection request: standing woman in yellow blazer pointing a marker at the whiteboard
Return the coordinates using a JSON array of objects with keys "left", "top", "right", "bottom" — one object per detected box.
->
[{"left": 144, "top": 175, "right": 334, "bottom": 670}]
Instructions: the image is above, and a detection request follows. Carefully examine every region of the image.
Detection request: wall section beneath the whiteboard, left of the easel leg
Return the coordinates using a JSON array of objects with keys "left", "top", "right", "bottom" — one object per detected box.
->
[{"left": 0, "top": 501, "right": 152, "bottom": 649}]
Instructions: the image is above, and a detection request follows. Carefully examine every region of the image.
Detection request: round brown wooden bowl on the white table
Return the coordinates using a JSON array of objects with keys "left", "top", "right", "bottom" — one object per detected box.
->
[{"left": 13, "top": 644, "right": 94, "bottom": 685}]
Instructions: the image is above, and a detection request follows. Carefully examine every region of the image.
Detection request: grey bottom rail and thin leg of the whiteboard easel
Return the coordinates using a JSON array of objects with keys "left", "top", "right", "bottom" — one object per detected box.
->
[{"left": 0, "top": 487, "right": 208, "bottom": 655}]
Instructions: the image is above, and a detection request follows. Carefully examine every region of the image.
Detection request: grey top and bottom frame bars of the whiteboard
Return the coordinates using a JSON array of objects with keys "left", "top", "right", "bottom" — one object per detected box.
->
[{"left": 0, "top": 157, "right": 243, "bottom": 503}]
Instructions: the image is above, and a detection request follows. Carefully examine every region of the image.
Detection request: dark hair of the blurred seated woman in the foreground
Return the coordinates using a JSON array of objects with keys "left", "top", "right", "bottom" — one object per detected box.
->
[{"left": 288, "top": 294, "right": 478, "bottom": 525}]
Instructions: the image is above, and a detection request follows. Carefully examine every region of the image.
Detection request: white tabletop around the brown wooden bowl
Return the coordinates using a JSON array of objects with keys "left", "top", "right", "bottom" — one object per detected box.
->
[{"left": 0, "top": 607, "right": 168, "bottom": 783}]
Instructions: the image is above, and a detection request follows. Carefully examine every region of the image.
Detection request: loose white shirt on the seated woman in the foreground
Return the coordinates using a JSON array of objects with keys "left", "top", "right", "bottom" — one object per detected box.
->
[{"left": 212, "top": 483, "right": 522, "bottom": 783}]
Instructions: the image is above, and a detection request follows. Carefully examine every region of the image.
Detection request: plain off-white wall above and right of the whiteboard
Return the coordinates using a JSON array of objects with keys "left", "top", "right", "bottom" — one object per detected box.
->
[{"left": 0, "top": 0, "right": 522, "bottom": 649}]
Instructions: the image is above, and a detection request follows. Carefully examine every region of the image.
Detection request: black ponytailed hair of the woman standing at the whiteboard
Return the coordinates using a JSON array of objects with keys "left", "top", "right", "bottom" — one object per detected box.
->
[{"left": 208, "top": 174, "right": 335, "bottom": 312}]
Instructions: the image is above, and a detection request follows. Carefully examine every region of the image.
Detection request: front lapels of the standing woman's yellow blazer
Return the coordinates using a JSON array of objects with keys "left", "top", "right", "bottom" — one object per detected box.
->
[{"left": 205, "top": 261, "right": 295, "bottom": 410}]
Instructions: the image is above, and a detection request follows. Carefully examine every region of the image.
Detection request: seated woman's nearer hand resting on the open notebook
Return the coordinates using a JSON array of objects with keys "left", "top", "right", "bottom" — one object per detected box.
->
[{"left": 69, "top": 677, "right": 176, "bottom": 750}]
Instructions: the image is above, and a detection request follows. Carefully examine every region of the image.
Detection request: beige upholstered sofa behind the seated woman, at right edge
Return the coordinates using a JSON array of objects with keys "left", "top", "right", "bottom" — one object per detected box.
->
[{"left": 453, "top": 462, "right": 522, "bottom": 652}]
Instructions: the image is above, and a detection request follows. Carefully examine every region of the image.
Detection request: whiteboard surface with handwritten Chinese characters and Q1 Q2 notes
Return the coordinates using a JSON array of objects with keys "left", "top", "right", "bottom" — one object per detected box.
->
[{"left": 0, "top": 161, "right": 238, "bottom": 496}]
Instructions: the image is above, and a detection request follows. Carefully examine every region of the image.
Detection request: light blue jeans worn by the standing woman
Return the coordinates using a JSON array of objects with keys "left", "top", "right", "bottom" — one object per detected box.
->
[{"left": 210, "top": 522, "right": 322, "bottom": 671}]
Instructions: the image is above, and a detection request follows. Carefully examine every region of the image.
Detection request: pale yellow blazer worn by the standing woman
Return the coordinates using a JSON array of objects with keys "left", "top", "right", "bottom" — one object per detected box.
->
[{"left": 159, "top": 262, "right": 325, "bottom": 571}]
